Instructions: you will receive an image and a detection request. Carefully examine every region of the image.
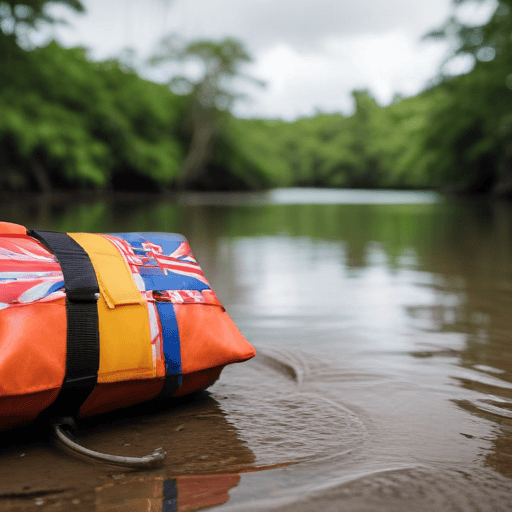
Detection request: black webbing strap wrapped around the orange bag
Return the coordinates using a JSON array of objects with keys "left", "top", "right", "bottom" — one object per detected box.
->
[{"left": 28, "top": 230, "right": 99, "bottom": 417}]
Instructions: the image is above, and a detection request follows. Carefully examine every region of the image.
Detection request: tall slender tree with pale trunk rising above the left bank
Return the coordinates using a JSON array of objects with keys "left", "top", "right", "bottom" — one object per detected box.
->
[{"left": 151, "top": 37, "right": 262, "bottom": 189}]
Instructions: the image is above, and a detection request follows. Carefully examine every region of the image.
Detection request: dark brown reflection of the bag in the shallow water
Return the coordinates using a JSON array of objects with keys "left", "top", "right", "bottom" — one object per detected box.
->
[{"left": 0, "top": 394, "right": 255, "bottom": 512}]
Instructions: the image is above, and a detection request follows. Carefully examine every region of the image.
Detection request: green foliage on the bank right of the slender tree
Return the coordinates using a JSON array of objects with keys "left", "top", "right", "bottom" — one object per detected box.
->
[{"left": 222, "top": 0, "right": 512, "bottom": 195}]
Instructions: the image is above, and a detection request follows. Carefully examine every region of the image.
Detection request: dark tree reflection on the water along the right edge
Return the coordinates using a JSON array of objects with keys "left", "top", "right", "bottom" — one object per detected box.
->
[{"left": 400, "top": 199, "right": 512, "bottom": 477}]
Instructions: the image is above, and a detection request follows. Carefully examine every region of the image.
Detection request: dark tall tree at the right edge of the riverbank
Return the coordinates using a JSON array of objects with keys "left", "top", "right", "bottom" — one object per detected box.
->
[{"left": 426, "top": 0, "right": 512, "bottom": 195}]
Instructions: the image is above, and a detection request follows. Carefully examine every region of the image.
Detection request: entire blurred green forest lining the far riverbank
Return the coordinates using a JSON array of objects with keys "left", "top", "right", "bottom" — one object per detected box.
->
[{"left": 0, "top": 0, "right": 512, "bottom": 195}]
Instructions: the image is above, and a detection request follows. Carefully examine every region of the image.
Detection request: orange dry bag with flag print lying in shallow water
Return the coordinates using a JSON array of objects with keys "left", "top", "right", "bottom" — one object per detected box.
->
[{"left": 0, "top": 222, "right": 255, "bottom": 429}]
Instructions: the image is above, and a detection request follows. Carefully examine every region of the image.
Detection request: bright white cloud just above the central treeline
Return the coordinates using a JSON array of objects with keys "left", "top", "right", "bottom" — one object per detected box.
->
[{"left": 232, "top": 30, "right": 445, "bottom": 119}]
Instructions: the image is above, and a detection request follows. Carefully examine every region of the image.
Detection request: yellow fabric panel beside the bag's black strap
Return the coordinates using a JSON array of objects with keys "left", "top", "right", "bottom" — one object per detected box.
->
[{"left": 68, "top": 233, "right": 156, "bottom": 382}]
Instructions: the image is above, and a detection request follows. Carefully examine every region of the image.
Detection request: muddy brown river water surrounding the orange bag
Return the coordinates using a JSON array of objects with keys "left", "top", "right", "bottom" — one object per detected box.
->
[{"left": 0, "top": 189, "right": 512, "bottom": 512}]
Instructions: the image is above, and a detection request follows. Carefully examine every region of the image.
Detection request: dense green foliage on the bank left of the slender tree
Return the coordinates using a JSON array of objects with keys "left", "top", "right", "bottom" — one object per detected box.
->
[{"left": 0, "top": 43, "right": 184, "bottom": 191}]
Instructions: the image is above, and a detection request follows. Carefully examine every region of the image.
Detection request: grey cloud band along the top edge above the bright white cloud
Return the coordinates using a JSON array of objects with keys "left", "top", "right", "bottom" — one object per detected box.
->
[{"left": 165, "top": 0, "right": 450, "bottom": 51}]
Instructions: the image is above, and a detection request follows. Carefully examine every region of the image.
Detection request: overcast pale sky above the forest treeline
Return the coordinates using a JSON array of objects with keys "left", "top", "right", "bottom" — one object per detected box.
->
[{"left": 45, "top": 0, "right": 492, "bottom": 120}]
